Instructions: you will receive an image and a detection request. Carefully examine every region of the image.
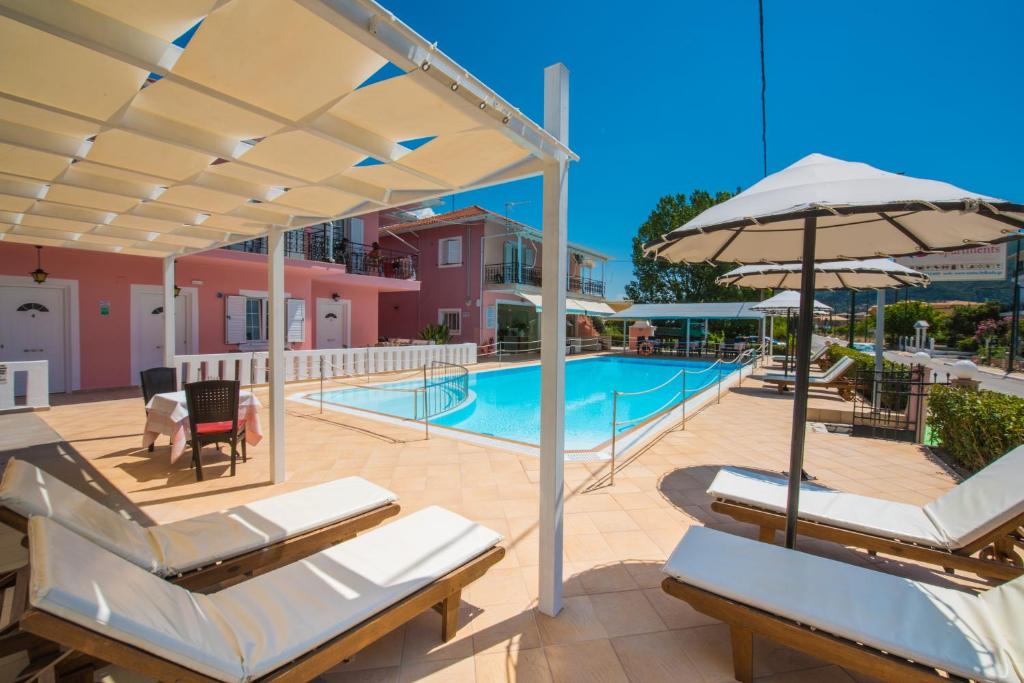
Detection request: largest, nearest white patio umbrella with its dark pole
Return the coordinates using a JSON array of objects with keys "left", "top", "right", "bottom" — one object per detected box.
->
[{"left": 645, "top": 154, "right": 1024, "bottom": 548}]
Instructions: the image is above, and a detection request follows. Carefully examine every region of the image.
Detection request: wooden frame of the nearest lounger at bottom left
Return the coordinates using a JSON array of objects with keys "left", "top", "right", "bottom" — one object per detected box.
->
[{"left": 7, "top": 546, "right": 505, "bottom": 682}]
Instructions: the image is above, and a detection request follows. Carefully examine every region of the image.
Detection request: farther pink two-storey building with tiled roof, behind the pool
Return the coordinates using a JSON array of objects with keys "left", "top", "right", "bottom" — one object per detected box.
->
[{"left": 379, "top": 206, "right": 612, "bottom": 345}]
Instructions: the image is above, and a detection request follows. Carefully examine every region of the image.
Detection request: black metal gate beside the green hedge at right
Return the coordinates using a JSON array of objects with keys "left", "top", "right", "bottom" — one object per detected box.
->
[{"left": 853, "top": 366, "right": 948, "bottom": 442}]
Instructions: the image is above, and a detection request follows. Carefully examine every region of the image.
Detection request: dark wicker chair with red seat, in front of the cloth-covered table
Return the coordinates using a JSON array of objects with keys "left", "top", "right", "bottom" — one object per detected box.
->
[{"left": 185, "top": 380, "right": 247, "bottom": 481}]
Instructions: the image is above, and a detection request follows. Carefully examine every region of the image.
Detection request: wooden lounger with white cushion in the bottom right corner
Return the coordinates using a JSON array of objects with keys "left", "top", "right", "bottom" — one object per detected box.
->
[{"left": 662, "top": 526, "right": 1024, "bottom": 683}]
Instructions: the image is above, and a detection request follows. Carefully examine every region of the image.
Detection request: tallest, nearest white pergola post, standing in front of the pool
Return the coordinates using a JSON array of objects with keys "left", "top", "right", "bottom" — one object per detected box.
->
[{"left": 539, "top": 63, "right": 569, "bottom": 616}]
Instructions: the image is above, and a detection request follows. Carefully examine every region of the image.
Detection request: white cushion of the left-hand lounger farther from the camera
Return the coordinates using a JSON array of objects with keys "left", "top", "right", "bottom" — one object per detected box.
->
[{"left": 0, "top": 459, "right": 398, "bottom": 577}]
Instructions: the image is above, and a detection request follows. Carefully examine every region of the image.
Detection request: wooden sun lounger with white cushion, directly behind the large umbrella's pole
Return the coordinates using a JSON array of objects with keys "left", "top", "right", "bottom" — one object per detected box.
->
[{"left": 708, "top": 445, "right": 1024, "bottom": 581}]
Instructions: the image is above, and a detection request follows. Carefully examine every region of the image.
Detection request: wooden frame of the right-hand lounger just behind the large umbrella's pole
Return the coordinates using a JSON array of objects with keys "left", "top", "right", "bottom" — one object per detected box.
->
[{"left": 711, "top": 498, "right": 1024, "bottom": 581}]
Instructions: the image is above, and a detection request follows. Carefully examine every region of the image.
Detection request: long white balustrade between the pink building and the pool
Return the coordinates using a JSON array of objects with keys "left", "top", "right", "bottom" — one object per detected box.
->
[{"left": 174, "top": 344, "right": 476, "bottom": 385}]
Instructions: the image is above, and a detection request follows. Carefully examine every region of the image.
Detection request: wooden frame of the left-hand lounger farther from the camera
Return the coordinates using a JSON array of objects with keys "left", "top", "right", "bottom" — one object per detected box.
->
[{"left": 0, "top": 503, "right": 401, "bottom": 592}]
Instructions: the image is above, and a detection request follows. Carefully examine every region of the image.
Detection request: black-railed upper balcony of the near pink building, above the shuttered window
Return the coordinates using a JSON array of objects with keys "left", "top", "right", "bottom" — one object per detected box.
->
[{"left": 224, "top": 227, "right": 420, "bottom": 280}]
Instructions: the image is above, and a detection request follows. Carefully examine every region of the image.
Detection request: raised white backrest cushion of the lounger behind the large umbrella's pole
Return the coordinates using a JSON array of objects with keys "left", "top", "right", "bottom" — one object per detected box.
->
[{"left": 925, "top": 445, "right": 1024, "bottom": 548}]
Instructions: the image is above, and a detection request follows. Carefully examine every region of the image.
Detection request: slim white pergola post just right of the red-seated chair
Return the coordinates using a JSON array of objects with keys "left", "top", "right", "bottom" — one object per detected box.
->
[{"left": 266, "top": 227, "right": 287, "bottom": 483}]
